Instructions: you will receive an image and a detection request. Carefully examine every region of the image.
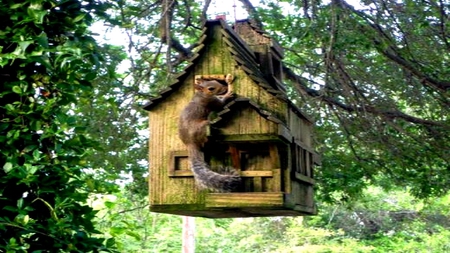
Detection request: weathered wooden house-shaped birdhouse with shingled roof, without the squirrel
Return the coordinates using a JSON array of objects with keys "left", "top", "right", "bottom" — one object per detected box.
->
[{"left": 144, "top": 20, "right": 318, "bottom": 218}]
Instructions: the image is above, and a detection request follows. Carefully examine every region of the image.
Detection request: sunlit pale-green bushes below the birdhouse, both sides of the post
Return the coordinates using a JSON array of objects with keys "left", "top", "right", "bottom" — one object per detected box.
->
[{"left": 95, "top": 187, "right": 450, "bottom": 253}]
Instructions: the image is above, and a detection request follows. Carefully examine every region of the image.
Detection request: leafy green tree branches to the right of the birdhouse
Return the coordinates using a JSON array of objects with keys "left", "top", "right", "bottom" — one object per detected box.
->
[{"left": 258, "top": 0, "right": 450, "bottom": 201}]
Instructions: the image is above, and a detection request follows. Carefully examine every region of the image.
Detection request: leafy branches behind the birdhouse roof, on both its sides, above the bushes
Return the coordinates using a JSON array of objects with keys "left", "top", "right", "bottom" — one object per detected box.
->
[{"left": 97, "top": 0, "right": 450, "bottom": 201}]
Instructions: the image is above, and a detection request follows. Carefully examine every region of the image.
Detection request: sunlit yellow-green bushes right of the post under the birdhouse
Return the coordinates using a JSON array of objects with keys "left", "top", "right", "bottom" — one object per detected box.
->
[{"left": 196, "top": 188, "right": 450, "bottom": 252}]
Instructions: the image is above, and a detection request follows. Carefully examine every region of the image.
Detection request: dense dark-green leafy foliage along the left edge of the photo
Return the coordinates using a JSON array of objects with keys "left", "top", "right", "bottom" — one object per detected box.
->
[{"left": 0, "top": 1, "right": 116, "bottom": 252}]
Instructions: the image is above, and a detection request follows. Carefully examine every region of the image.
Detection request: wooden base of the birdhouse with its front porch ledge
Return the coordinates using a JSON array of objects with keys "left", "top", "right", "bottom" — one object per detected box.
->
[{"left": 150, "top": 192, "right": 317, "bottom": 218}]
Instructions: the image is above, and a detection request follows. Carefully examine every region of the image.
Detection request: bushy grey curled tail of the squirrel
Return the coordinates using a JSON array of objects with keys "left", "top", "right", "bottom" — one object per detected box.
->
[{"left": 189, "top": 146, "right": 241, "bottom": 192}]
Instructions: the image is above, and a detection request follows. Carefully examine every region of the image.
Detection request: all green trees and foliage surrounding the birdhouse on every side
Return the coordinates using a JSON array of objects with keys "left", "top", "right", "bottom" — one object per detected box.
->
[{"left": 0, "top": 0, "right": 450, "bottom": 252}]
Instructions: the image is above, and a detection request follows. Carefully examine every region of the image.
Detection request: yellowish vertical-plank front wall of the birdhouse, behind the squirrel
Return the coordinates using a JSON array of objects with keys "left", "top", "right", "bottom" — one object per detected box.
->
[{"left": 149, "top": 23, "right": 309, "bottom": 210}]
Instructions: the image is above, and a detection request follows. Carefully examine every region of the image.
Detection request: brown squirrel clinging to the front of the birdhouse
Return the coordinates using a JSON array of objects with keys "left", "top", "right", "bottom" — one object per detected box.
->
[{"left": 178, "top": 75, "right": 241, "bottom": 192}]
